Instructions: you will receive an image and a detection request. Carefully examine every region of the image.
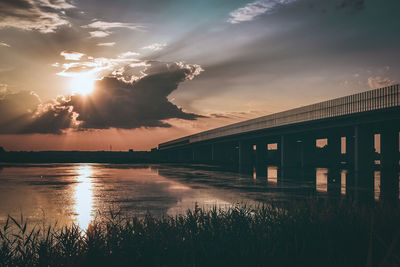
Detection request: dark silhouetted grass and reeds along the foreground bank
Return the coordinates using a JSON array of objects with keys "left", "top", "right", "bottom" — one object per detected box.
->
[{"left": 0, "top": 199, "right": 400, "bottom": 266}]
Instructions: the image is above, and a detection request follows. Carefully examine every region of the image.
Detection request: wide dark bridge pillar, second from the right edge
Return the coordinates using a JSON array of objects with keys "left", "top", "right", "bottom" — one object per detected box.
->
[{"left": 354, "top": 125, "right": 375, "bottom": 172}]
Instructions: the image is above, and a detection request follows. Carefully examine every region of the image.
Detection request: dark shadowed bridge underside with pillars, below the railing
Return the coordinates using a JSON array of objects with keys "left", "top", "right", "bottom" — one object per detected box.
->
[{"left": 158, "top": 108, "right": 400, "bottom": 171}]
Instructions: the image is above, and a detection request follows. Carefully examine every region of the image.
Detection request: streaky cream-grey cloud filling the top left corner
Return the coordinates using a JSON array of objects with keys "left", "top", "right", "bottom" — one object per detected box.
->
[{"left": 0, "top": 0, "right": 75, "bottom": 33}]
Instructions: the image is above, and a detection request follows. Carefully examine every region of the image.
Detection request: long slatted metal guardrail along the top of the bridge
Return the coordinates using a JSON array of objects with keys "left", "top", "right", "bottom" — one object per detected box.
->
[{"left": 159, "top": 84, "right": 400, "bottom": 149}]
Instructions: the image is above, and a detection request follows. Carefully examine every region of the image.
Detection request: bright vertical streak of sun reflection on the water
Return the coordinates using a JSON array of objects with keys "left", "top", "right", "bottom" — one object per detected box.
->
[{"left": 75, "top": 165, "right": 93, "bottom": 229}]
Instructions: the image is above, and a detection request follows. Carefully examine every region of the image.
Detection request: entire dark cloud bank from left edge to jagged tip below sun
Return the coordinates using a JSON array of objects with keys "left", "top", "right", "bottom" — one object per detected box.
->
[{"left": 0, "top": 62, "right": 202, "bottom": 134}]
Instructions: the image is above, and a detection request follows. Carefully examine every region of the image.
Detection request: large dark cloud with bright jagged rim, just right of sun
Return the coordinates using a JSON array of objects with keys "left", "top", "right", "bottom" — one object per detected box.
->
[{"left": 64, "top": 62, "right": 201, "bottom": 129}]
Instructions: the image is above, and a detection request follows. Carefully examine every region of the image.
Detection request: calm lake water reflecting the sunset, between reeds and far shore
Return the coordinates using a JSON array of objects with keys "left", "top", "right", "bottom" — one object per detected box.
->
[{"left": 0, "top": 163, "right": 399, "bottom": 228}]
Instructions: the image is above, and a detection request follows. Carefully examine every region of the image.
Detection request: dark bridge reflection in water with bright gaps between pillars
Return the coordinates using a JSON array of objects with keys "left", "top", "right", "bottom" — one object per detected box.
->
[{"left": 231, "top": 165, "right": 400, "bottom": 202}]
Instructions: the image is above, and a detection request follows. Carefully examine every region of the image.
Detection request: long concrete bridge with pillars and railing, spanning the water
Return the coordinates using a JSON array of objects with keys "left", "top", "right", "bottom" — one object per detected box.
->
[{"left": 157, "top": 84, "right": 400, "bottom": 175}]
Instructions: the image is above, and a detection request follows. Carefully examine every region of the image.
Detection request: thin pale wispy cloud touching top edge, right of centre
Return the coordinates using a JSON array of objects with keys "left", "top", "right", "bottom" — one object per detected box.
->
[{"left": 227, "top": 0, "right": 296, "bottom": 24}]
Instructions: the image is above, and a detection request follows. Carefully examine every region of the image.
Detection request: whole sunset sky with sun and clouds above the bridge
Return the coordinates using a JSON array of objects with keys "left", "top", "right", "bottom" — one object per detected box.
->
[{"left": 0, "top": 0, "right": 400, "bottom": 151}]
